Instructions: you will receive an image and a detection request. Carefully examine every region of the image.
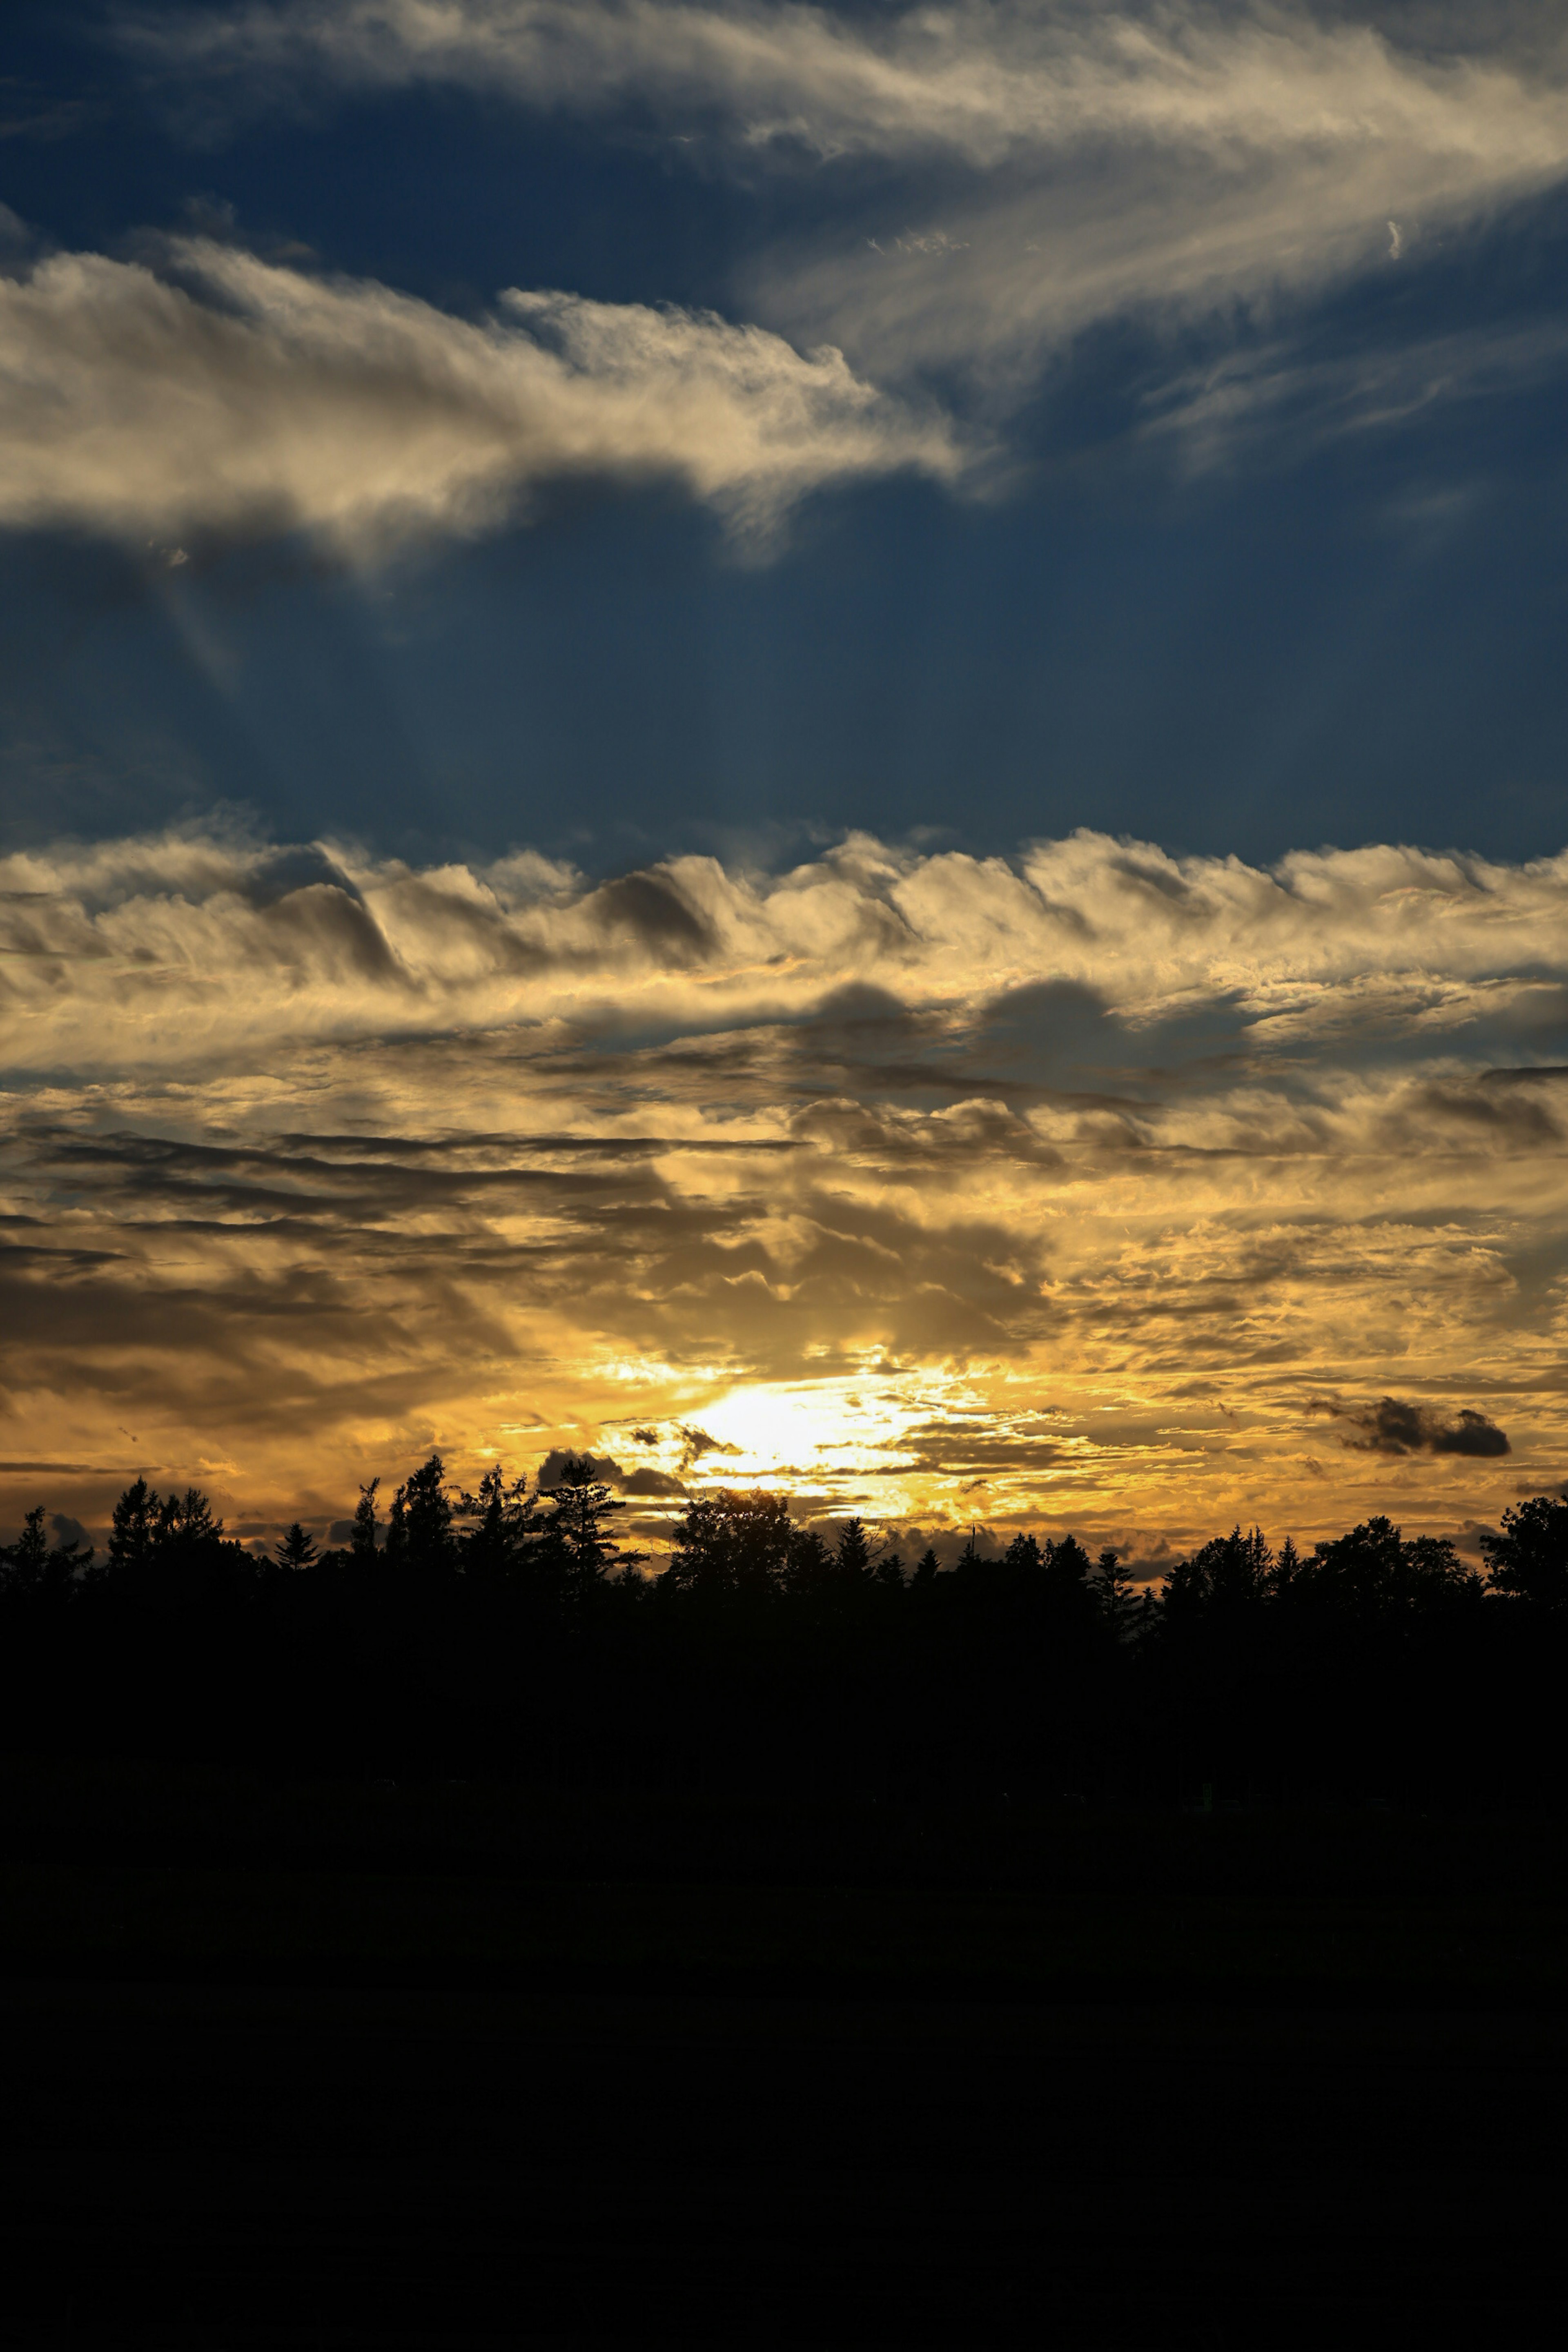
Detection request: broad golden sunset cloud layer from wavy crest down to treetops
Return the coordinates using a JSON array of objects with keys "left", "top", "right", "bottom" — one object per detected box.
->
[{"left": 0, "top": 830, "right": 1568, "bottom": 1557}]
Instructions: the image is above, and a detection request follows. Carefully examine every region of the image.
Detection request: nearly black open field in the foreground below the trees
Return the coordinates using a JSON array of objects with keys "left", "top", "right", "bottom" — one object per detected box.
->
[{"left": 0, "top": 1766, "right": 1568, "bottom": 2352}]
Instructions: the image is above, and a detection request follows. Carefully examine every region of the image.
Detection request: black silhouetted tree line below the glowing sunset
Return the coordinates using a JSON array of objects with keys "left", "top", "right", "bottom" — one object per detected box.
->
[{"left": 0, "top": 1454, "right": 1568, "bottom": 1809}]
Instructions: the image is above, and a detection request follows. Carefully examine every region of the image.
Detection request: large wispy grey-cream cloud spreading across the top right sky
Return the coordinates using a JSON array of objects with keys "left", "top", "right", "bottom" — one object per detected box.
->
[{"left": 131, "top": 0, "right": 1568, "bottom": 393}]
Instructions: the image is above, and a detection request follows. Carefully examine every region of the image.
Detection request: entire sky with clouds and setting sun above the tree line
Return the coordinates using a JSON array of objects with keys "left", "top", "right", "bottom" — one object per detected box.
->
[{"left": 0, "top": 0, "right": 1568, "bottom": 1576}]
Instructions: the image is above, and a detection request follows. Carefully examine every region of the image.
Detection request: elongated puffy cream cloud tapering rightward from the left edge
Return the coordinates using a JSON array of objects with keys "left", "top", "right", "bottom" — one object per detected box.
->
[{"left": 0, "top": 238, "right": 959, "bottom": 555}]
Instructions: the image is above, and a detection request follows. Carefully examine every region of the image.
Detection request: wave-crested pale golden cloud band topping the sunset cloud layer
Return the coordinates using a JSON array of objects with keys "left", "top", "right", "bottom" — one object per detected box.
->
[{"left": 0, "top": 809, "right": 1568, "bottom": 1073}]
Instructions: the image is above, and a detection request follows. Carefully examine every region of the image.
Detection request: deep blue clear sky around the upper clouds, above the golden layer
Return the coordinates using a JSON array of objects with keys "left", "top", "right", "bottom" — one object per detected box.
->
[{"left": 0, "top": 5, "right": 1568, "bottom": 870}]
